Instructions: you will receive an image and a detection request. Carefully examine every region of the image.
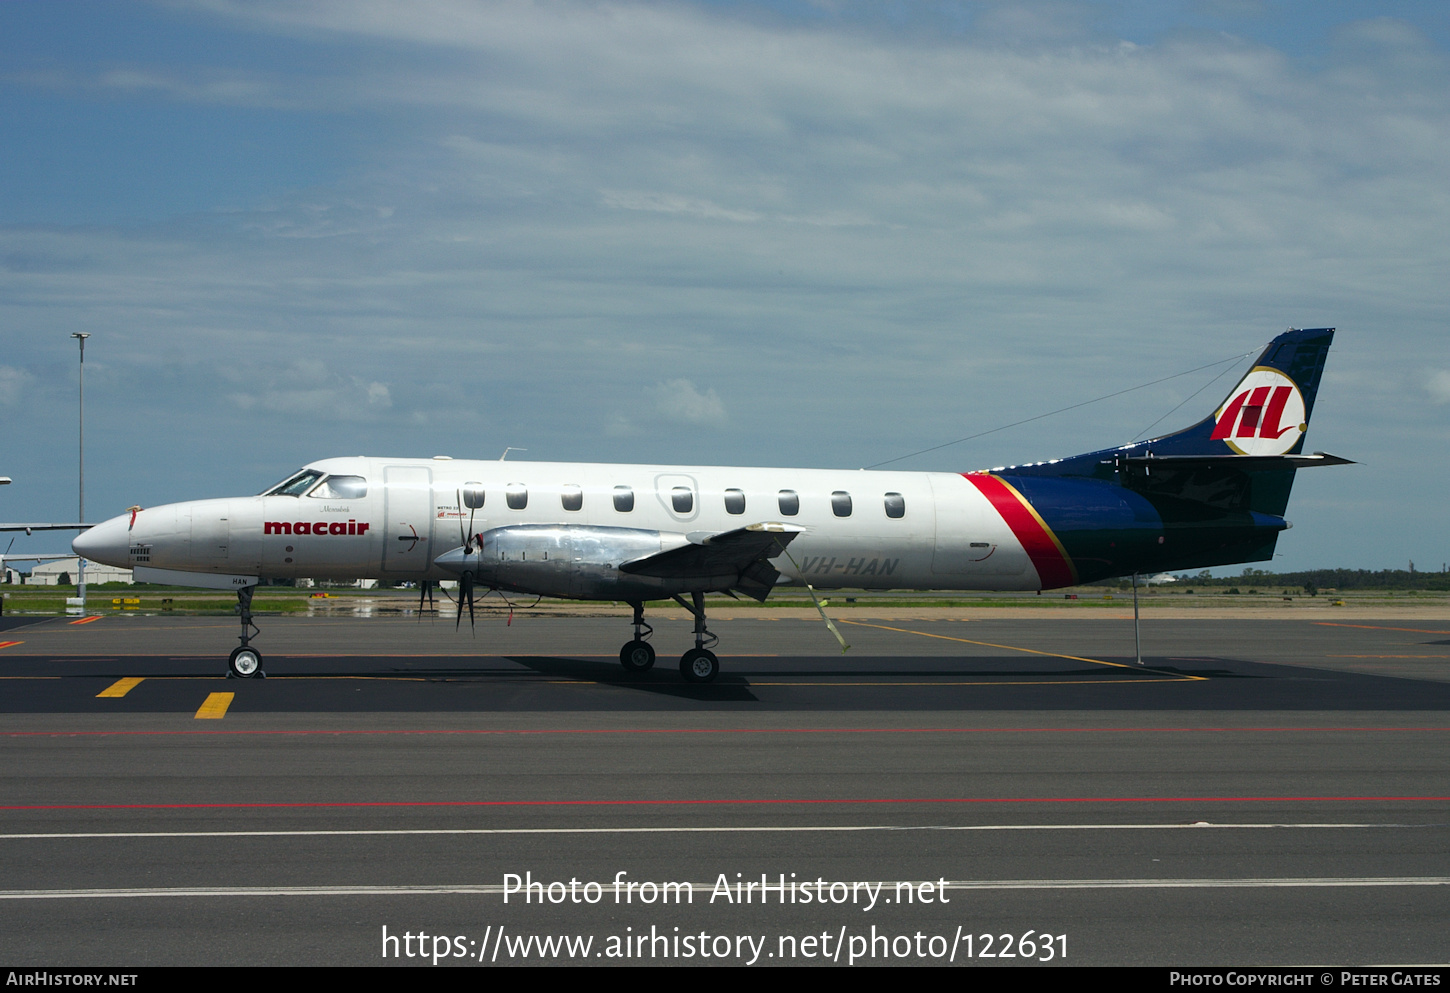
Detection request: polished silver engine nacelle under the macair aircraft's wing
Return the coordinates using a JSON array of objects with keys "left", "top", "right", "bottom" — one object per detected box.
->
[{"left": 435, "top": 525, "right": 707, "bottom": 600}]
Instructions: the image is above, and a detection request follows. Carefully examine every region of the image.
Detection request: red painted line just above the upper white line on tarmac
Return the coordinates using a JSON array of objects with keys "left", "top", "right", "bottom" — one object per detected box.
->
[{"left": 0, "top": 796, "right": 1450, "bottom": 810}]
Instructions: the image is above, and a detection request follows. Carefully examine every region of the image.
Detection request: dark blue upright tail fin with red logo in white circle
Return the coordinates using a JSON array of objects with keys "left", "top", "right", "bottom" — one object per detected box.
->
[{"left": 1134, "top": 328, "right": 1334, "bottom": 455}]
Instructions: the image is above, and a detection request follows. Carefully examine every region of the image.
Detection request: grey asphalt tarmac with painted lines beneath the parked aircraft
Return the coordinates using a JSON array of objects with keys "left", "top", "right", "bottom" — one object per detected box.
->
[{"left": 0, "top": 612, "right": 1450, "bottom": 968}]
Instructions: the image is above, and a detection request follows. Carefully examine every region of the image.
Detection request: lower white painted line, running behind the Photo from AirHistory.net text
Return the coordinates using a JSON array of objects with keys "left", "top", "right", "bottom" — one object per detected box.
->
[{"left": 0, "top": 876, "right": 1450, "bottom": 900}]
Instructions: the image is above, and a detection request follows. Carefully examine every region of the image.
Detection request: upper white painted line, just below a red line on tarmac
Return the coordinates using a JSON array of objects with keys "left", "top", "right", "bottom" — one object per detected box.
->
[{"left": 0, "top": 820, "right": 1415, "bottom": 841}]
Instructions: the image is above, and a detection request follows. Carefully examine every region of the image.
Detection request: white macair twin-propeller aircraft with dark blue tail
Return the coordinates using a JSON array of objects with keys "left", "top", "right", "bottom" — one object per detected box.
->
[{"left": 73, "top": 328, "right": 1346, "bottom": 681}]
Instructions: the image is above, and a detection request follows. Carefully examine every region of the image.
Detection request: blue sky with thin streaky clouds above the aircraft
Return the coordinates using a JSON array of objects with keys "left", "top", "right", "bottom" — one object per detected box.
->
[{"left": 0, "top": 0, "right": 1450, "bottom": 573}]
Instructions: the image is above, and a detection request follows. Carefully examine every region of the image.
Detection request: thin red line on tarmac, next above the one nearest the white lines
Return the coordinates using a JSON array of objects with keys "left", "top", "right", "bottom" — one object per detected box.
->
[{"left": 0, "top": 725, "right": 1450, "bottom": 738}]
